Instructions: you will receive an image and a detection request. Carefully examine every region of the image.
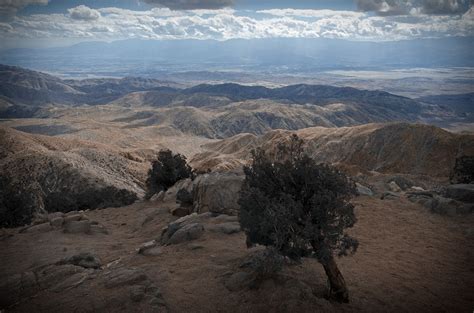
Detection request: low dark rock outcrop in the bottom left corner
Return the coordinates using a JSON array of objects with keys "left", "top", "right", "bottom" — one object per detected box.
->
[{"left": 0, "top": 253, "right": 167, "bottom": 312}]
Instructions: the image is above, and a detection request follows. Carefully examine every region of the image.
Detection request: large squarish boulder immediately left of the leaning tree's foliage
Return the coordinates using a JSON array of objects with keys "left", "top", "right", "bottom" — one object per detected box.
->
[{"left": 193, "top": 173, "right": 244, "bottom": 215}]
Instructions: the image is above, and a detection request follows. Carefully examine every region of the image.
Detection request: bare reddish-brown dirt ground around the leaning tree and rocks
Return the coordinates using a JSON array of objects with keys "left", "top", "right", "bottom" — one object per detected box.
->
[{"left": 0, "top": 196, "right": 474, "bottom": 312}]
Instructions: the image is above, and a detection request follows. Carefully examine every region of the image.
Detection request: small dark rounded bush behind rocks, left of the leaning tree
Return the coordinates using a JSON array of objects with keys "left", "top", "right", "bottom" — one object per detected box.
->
[{"left": 147, "top": 150, "right": 194, "bottom": 197}]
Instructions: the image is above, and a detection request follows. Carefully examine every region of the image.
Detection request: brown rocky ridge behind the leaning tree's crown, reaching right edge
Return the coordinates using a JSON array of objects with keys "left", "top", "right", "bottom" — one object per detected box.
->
[{"left": 191, "top": 123, "right": 474, "bottom": 177}]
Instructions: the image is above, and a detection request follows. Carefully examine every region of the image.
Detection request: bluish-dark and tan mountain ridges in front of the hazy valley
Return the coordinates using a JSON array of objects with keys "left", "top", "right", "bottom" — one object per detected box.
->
[{"left": 0, "top": 65, "right": 472, "bottom": 138}]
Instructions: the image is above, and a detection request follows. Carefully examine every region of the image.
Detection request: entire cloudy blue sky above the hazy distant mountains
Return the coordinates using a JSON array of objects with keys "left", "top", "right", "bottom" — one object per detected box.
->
[{"left": 0, "top": 0, "right": 474, "bottom": 48}]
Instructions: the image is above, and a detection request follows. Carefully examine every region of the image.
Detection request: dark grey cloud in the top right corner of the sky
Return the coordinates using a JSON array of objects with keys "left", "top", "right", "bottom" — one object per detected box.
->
[{"left": 356, "top": 0, "right": 472, "bottom": 16}]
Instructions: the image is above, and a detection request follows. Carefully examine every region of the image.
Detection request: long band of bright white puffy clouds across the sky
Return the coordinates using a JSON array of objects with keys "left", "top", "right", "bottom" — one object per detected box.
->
[{"left": 0, "top": 8, "right": 474, "bottom": 41}]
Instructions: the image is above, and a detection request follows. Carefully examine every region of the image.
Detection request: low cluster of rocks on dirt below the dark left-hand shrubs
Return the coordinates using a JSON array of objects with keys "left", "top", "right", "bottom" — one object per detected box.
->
[{"left": 20, "top": 211, "right": 108, "bottom": 234}]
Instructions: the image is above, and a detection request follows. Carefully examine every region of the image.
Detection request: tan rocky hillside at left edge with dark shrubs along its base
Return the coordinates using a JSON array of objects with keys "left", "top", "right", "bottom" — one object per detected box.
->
[{"left": 0, "top": 128, "right": 148, "bottom": 226}]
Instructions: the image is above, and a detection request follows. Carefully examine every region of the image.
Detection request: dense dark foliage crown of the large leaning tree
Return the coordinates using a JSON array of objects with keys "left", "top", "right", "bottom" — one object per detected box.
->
[{"left": 239, "top": 135, "right": 358, "bottom": 264}]
